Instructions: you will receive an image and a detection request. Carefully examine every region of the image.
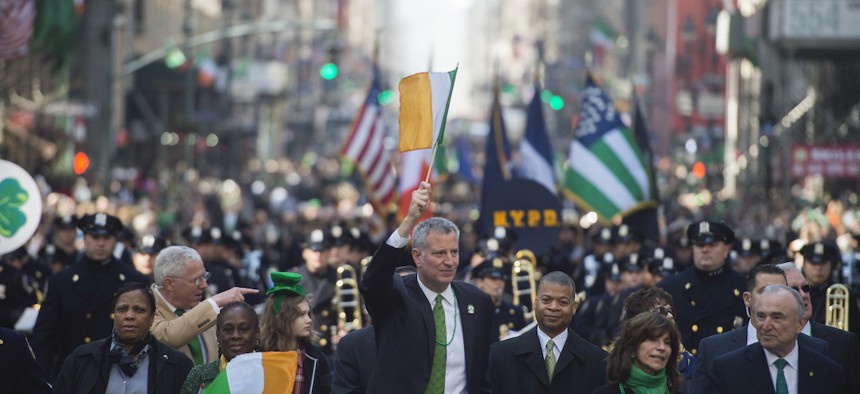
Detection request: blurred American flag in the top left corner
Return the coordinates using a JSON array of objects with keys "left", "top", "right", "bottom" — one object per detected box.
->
[{"left": 0, "top": 0, "right": 36, "bottom": 60}]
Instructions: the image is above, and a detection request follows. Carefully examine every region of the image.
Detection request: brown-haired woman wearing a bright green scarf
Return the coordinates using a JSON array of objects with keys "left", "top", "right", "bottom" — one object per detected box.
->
[{"left": 594, "top": 312, "right": 682, "bottom": 394}]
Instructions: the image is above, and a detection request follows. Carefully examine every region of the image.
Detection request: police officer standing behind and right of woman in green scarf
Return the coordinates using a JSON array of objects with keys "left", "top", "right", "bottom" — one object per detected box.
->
[{"left": 657, "top": 220, "right": 747, "bottom": 355}]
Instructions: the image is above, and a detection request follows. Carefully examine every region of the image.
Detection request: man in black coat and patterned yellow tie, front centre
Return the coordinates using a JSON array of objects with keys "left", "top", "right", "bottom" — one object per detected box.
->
[{"left": 489, "top": 271, "right": 607, "bottom": 394}]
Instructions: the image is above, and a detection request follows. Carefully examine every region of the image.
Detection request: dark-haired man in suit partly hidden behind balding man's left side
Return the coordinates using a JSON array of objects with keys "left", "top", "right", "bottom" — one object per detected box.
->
[{"left": 688, "top": 264, "right": 827, "bottom": 393}]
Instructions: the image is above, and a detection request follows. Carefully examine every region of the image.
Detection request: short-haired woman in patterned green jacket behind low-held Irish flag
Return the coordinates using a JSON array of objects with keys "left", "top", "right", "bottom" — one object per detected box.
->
[{"left": 182, "top": 301, "right": 260, "bottom": 394}]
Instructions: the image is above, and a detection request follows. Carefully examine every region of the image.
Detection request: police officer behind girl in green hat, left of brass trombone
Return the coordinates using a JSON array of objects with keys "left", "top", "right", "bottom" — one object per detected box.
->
[{"left": 294, "top": 229, "right": 337, "bottom": 355}]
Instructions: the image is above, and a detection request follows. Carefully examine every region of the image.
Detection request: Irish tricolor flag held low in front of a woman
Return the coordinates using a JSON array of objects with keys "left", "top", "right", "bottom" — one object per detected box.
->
[{"left": 203, "top": 351, "right": 298, "bottom": 394}]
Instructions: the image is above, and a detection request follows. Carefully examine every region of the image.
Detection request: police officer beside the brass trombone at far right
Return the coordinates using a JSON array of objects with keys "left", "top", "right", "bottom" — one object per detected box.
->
[{"left": 800, "top": 240, "right": 860, "bottom": 333}]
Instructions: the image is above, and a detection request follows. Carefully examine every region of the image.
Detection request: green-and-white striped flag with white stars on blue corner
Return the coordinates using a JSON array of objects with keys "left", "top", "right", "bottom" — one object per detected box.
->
[{"left": 562, "top": 75, "right": 655, "bottom": 222}]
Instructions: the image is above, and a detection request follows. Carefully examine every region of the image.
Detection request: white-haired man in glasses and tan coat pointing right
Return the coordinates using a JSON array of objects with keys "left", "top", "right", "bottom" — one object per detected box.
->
[{"left": 151, "top": 246, "right": 258, "bottom": 365}]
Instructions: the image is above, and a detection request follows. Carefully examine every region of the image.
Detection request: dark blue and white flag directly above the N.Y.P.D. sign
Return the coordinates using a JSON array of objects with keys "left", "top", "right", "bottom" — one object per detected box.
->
[{"left": 517, "top": 84, "right": 558, "bottom": 193}]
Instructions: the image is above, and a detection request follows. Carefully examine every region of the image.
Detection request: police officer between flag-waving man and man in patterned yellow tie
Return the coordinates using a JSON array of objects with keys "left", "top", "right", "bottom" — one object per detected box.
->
[{"left": 472, "top": 258, "right": 526, "bottom": 344}]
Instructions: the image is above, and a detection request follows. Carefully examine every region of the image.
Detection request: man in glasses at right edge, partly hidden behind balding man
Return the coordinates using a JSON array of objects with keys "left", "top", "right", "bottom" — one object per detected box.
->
[{"left": 778, "top": 262, "right": 860, "bottom": 394}]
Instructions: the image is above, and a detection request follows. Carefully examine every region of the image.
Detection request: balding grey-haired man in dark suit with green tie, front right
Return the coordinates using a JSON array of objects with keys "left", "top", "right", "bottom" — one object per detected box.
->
[{"left": 708, "top": 285, "right": 845, "bottom": 394}]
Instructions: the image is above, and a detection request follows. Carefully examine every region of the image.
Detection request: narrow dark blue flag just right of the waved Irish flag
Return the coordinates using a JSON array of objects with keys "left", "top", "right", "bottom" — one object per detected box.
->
[{"left": 481, "top": 83, "right": 511, "bottom": 209}]
